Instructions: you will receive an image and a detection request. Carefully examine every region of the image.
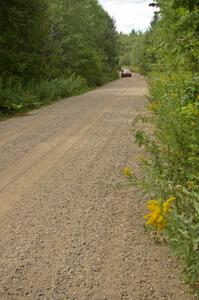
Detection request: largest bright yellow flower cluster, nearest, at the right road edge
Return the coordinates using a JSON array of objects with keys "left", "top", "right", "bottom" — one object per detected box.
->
[{"left": 144, "top": 197, "right": 175, "bottom": 231}]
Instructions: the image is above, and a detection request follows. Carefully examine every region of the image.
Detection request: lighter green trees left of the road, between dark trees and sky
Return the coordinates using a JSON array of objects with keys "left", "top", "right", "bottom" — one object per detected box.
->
[{"left": 46, "top": 0, "right": 117, "bottom": 85}]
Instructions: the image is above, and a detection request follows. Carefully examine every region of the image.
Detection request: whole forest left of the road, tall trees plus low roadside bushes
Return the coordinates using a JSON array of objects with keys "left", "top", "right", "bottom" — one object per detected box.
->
[{"left": 0, "top": 0, "right": 118, "bottom": 115}]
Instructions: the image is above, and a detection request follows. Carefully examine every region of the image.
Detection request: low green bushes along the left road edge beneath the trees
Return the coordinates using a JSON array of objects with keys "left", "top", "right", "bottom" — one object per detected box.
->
[{"left": 0, "top": 75, "right": 88, "bottom": 115}]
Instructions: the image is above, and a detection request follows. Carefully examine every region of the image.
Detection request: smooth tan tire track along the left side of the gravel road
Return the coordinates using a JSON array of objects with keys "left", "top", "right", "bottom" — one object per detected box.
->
[{"left": 0, "top": 90, "right": 125, "bottom": 214}]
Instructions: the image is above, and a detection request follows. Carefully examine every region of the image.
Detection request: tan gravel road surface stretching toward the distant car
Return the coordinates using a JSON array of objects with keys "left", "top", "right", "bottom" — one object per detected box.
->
[{"left": 0, "top": 75, "right": 196, "bottom": 300}]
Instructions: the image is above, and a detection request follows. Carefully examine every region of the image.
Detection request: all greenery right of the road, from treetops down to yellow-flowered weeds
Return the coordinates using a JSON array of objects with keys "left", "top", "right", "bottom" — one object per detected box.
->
[{"left": 119, "top": 0, "right": 199, "bottom": 290}]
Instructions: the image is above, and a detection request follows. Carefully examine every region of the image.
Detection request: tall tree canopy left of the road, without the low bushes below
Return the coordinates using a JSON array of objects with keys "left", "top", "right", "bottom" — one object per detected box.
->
[{"left": 0, "top": 0, "right": 117, "bottom": 85}]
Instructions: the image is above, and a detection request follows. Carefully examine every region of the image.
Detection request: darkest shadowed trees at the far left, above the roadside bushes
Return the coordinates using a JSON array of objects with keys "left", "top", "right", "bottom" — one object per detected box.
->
[{"left": 0, "top": 0, "right": 47, "bottom": 82}]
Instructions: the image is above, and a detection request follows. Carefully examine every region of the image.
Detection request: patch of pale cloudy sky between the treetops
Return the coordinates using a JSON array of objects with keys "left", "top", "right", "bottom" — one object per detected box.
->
[{"left": 99, "top": 0, "right": 155, "bottom": 33}]
